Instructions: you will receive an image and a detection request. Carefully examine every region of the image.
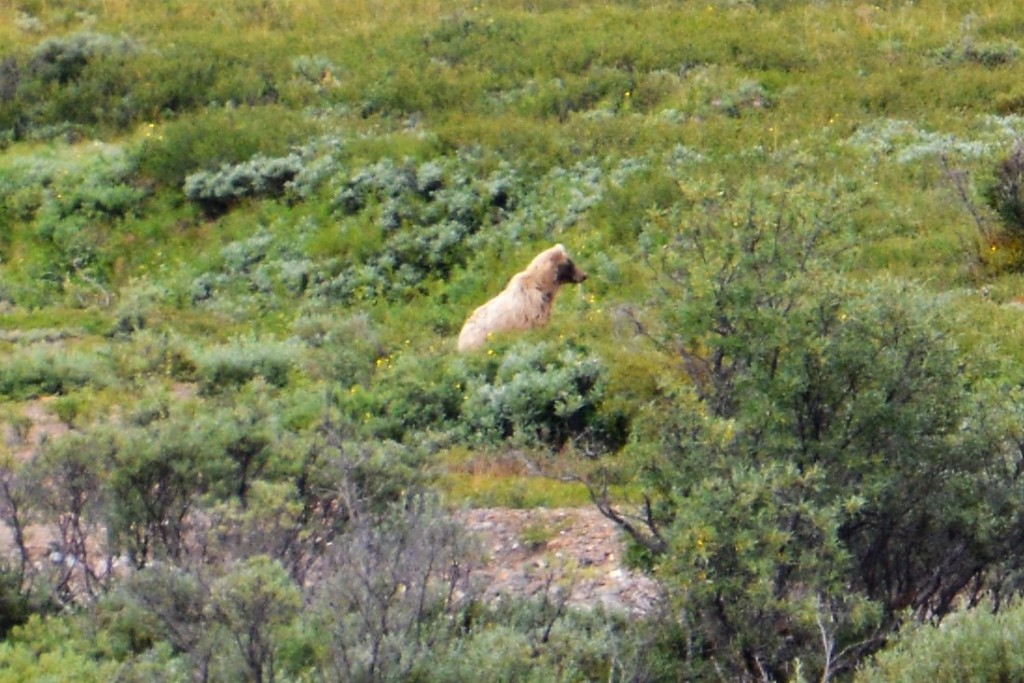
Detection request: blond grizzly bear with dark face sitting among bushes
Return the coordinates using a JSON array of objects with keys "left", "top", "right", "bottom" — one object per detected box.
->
[{"left": 459, "top": 245, "right": 587, "bottom": 351}]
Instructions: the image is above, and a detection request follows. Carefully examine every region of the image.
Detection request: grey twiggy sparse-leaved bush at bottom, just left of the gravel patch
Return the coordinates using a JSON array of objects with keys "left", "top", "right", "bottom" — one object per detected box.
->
[{"left": 308, "top": 499, "right": 476, "bottom": 680}]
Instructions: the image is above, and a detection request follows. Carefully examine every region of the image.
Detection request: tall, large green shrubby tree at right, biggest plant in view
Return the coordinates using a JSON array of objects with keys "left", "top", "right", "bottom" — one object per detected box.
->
[{"left": 599, "top": 179, "right": 1022, "bottom": 680}]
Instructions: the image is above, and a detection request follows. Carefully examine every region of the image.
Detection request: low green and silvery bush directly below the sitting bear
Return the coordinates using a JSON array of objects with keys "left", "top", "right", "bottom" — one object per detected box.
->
[{"left": 339, "top": 341, "right": 629, "bottom": 454}]
